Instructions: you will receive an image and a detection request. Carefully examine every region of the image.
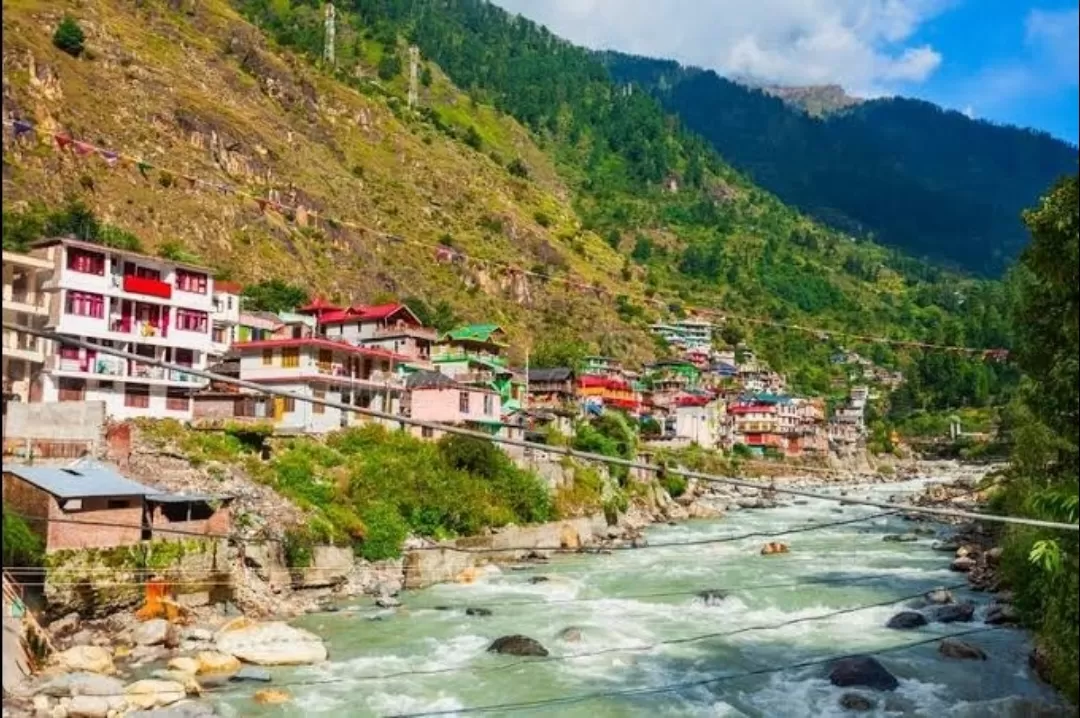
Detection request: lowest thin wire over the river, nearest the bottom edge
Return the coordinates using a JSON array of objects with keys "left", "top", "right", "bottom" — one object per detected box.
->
[{"left": 387, "top": 627, "right": 1001, "bottom": 718}]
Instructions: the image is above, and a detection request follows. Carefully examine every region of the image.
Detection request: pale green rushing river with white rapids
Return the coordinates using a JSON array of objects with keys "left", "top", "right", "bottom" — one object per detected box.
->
[{"left": 212, "top": 482, "right": 1071, "bottom": 718}]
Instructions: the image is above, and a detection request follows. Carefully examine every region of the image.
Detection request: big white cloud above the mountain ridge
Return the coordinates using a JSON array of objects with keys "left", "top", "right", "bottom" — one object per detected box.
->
[{"left": 495, "top": 0, "right": 955, "bottom": 95}]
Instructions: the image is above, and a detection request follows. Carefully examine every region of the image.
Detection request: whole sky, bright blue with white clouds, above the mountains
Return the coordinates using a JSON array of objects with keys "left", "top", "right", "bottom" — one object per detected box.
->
[{"left": 495, "top": 0, "right": 1080, "bottom": 144}]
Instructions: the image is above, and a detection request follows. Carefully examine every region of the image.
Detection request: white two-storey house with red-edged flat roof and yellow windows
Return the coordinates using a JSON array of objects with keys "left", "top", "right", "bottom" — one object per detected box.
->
[{"left": 232, "top": 337, "right": 405, "bottom": 433}]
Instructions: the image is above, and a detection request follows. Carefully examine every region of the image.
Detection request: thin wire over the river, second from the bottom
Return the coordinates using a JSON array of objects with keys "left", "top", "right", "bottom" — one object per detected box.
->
[{"left": 252, "top": 584, "right": 967, "bottom": 686}]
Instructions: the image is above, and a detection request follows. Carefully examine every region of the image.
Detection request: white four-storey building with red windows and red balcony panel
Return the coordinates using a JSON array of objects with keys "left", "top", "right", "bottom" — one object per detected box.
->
[{"left": 31, "top": 239, "right": 214, "bottom": 420}]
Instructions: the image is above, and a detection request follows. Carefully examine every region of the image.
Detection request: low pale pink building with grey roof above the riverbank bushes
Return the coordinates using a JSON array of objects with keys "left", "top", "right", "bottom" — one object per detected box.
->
[{"left": 402, "top": 371, "right": 508, "bottom": 438}]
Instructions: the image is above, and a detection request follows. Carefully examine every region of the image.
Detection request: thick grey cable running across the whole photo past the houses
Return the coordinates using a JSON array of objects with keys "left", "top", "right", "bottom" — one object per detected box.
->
[{"left": 3, "top": 322, "right": 1067, "bottom": 531}]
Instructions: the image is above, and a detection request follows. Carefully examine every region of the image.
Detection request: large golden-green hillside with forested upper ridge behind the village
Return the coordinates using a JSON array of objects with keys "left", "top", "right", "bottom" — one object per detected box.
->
[{"left": 3, "top": 0, "right": 1008, "bottom": 397}]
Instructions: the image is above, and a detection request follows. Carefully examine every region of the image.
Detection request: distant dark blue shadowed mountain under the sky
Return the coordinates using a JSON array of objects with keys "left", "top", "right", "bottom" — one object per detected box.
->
[{"left": 600, "top": 53, "right": 1077, "bottom": 275}]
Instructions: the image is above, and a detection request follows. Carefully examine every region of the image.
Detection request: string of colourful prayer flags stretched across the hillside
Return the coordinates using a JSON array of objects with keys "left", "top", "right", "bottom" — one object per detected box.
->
[{"left": 3, "top": 120, "right": 1004, "bottom": 355}]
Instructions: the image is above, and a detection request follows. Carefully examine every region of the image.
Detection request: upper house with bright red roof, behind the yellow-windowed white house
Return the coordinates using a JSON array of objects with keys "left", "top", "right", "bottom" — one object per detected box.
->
[{"left": 319, "top": 303, "right": 437, "bottom": 368}]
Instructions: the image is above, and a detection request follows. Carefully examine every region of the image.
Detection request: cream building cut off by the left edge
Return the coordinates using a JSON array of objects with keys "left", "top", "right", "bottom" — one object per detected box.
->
[{"left": 3, "top": 252, "right": 53, "bottom": 404}]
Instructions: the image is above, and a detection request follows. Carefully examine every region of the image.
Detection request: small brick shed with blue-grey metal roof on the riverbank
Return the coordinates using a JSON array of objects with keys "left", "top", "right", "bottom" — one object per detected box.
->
[{"left": 3, "top": 460, "right": 231, "bottom": 553}]
